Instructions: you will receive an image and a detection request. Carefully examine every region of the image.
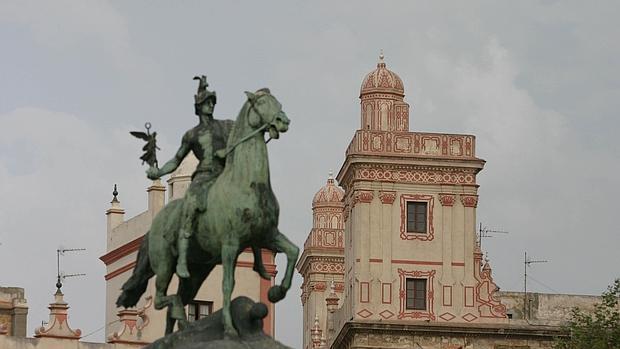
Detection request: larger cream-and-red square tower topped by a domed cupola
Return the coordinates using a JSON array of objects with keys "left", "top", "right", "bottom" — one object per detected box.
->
[{"left": 328, "top": 55, "right": 506, "bottom": 334}]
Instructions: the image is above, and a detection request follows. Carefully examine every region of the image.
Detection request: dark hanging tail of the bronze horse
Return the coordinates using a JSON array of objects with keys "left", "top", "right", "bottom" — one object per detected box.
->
[{"left": 116, "top": 232, "right": 155, "bottom": 308}]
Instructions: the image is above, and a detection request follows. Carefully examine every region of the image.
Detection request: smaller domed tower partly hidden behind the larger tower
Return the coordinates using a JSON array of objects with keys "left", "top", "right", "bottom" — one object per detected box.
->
[{"left": 297, "top": 173, "right": 344, "bottom": 349}]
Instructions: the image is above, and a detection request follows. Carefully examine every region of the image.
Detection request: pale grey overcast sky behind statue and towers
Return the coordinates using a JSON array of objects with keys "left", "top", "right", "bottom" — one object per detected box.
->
[{"left": 0, "top": 0, "right": 620, "bottom": 347}]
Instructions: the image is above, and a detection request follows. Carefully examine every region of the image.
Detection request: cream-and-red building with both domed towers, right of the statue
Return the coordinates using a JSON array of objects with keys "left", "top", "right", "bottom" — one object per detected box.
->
[{"left": 298, "top": 55, "right": 559, "bottom": 349}]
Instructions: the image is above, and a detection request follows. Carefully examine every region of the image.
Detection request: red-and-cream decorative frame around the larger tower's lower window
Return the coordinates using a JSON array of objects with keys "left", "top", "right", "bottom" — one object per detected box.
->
[{"left": 398, "top": 268, "right": 436, "bottom": 320}]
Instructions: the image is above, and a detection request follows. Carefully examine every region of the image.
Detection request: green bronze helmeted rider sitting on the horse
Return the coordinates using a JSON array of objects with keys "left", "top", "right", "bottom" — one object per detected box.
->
[{"left": 146, "top": 75, "right": 234, "bottom": 278}]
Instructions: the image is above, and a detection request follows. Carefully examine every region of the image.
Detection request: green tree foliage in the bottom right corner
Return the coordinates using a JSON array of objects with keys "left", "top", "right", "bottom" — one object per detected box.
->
[{"left": 555, "top": 279, "right": 620, "bottom": 349}]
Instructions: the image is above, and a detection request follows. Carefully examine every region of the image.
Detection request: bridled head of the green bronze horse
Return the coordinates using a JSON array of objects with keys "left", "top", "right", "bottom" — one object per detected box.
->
[{"left": 245, "top": 88, "right": 291, "bottom": 139}]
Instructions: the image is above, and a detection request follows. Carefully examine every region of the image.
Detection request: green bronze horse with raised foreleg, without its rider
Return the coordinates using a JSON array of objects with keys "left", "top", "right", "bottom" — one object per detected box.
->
[{"left": 116, "top": 89, "right": 299, "bottom": 337}]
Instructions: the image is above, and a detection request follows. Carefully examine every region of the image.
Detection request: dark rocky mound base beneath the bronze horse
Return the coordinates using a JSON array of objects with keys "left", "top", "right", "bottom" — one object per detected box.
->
[{"left": 145, "top": 297, "right": 291, "bottom": 349}]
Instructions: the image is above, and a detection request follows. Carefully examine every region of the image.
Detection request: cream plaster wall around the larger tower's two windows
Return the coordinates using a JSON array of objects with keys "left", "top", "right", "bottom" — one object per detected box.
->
[{"left": 347, "top": 182, "right": 486, "bottom": 321}]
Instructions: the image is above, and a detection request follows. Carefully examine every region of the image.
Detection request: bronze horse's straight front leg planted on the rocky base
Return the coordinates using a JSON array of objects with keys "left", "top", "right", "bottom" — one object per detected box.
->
[{"left": 222, "top": 238, "right": 239, "bottom": 338}]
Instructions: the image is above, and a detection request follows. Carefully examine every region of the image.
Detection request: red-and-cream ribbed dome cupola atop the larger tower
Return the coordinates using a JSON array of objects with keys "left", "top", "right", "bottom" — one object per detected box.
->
[{"left": 360, "top": 52, "right": 409, "bottom": 132}]
